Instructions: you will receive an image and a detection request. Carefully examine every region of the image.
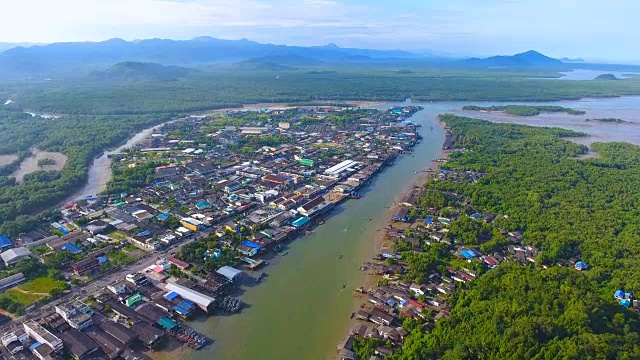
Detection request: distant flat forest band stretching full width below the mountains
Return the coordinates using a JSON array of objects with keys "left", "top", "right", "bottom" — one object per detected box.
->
[{"left": 0, "top": 66, "right": 640, "bottom": 115}]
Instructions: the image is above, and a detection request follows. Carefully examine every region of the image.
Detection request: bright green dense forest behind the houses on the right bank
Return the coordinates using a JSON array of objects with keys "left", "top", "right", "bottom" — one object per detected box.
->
[{"left": 393, "top": 115, "right": 640, "bottom": 360}]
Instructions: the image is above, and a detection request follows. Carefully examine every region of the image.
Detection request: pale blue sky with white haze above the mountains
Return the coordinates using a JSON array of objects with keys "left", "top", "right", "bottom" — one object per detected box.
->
[{"left": 0, "top": 0, "right": 640, "bottom": 62}]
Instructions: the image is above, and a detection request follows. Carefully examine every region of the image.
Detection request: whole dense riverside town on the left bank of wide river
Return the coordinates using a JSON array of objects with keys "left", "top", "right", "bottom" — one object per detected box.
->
[{"left": 0, "top": 106, "right": 421, "bottom": 360}]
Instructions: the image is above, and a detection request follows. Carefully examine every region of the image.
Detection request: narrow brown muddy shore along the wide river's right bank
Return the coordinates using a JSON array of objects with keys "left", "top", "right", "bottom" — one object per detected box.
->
[{"left": 330, "top": 116, "right": 451, "bottom": 360}]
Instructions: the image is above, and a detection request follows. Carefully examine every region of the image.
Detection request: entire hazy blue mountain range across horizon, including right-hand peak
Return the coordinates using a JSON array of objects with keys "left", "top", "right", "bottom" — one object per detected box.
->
[{"left": 0, "top": 36, "right": 592, "bottom": 78}]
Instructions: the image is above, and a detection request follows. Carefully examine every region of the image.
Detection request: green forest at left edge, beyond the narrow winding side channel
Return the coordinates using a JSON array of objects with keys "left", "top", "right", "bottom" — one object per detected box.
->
[{"left": 0, "top": 111, "right": 171, "bottom": 236}]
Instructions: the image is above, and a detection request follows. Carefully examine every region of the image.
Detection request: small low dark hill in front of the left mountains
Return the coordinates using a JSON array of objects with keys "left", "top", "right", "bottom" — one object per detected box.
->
[{"left": 91, "top": 61, "right": 199, "bottom": 81}]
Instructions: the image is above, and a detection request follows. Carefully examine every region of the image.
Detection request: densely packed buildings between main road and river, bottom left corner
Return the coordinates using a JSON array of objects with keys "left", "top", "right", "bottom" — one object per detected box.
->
[{"left": 1, "top": 259, "right": 242, "bottom": 360}]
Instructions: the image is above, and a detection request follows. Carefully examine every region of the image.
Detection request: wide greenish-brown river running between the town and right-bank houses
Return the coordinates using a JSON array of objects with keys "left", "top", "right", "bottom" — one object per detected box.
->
[{"left": 145, "top": 104, "right": 446, "bottom": 360}]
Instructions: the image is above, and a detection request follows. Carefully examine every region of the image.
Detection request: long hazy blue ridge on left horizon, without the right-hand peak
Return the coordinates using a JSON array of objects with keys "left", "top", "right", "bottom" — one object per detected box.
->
[{"left": 0, "top": 37, "right": 419, "bottom": 75}]
